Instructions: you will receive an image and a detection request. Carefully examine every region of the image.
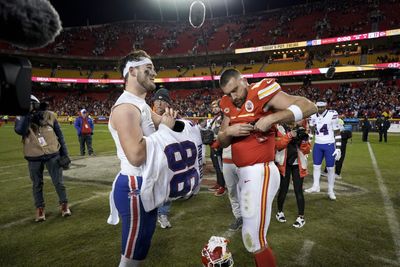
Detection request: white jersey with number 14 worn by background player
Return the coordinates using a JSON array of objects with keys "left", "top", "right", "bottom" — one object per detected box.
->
[{"left": 310, "top": 110, "right": 340, "bottom": 144}]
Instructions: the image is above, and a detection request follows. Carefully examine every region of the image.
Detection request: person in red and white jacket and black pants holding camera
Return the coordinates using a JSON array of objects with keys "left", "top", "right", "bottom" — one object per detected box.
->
[{"left": 275, "top": 121, "right": 311, "bottom": 228}]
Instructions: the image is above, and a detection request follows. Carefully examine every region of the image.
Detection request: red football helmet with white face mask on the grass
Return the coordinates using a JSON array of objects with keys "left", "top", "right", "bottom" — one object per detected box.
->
[{"left": 201, "top": 236, "right": 233, "bottom": 267}]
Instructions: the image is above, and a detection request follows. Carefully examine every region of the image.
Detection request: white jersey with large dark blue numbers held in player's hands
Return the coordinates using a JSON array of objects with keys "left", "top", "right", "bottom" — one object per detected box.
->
[{"left": 140, "top": 120, "right": 203, "bottom": 211}]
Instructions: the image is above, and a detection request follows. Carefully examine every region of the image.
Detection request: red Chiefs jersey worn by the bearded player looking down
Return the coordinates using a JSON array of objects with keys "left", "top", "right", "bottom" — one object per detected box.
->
[{"left": 220, "top": 79, "right": 281, "bottom": 167}]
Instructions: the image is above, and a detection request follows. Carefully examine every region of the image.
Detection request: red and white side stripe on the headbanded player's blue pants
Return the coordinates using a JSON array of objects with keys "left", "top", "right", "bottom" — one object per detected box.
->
[{"left": 124, "top": 176, "right": 140, "bottom": 259}]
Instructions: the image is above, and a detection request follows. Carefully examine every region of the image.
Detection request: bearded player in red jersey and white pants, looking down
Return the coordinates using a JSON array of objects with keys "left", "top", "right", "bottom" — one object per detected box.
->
[{"left": 218, "top": 69, "right": 317, "bottom": 267}]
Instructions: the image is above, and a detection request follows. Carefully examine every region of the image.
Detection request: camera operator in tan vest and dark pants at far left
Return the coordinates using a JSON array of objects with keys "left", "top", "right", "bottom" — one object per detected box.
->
[{"left": 14, "top": 95, "right": 71, "bottom": 222}]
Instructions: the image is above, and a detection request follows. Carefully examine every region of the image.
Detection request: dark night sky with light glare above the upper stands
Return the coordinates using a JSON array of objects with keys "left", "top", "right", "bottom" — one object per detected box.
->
[{"left": 50, "top": 0, "right": 310, "bottom": 27}]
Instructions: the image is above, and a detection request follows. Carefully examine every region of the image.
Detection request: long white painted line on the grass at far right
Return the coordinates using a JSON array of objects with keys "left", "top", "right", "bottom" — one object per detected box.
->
[{"left": 367, "top": 142, "right": 400, "bottom": 264}]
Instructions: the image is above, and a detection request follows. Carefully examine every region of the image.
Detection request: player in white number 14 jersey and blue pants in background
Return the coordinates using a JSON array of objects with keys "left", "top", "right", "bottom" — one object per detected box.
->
[{"left": 305, "top": 101, "right": 342, "bottom": 200}]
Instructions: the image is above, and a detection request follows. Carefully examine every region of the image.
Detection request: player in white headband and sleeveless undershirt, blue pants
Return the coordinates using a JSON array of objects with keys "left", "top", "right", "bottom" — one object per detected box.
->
[{"left": 108, "top": 50, "right": 177, "bottom": 266}]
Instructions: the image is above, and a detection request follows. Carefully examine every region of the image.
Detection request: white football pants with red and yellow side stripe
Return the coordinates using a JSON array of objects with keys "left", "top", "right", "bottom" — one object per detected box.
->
[{"left": 238, "top": 161, "right": 280, "bottom": 252}]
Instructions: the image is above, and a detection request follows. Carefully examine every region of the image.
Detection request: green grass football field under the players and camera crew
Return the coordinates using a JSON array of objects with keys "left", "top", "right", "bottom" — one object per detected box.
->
[{"left": 0, "top": 123, "right": 400, "bottom": 267}]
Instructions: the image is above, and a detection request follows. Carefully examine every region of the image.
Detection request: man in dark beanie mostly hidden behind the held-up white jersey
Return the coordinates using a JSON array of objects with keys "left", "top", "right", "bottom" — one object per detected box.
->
[{"left": 153, "top": 88, "right": 172, "bottom": 229}]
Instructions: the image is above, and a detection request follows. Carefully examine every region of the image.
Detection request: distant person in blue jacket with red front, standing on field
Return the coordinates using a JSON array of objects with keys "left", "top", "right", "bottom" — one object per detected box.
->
[{"left": 74, "top": 109, "right": 94, "bottom": 156}]
